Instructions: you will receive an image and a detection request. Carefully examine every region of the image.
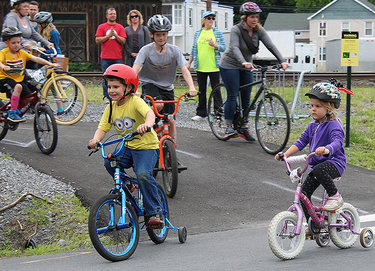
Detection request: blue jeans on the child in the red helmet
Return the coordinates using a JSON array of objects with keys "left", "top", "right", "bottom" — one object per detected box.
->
[{"left": 104, "top": 148, "right": 161, "bottom": 216}]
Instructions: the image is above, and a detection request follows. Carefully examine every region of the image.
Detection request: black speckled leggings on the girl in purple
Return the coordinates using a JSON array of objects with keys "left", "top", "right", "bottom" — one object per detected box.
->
[{"left": 302, "top": 161, "right": 341, "bottom": 221}]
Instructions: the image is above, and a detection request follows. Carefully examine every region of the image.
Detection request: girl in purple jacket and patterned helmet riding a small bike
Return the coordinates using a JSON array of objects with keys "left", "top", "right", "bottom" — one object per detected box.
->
[{"left": 275, "top": 83, "right": 346, "bottom": 221}]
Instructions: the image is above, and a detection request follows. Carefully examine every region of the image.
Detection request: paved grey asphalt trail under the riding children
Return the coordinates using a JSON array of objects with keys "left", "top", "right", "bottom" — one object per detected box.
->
[{"left": 0, "top": 122, "right": 375, "bottom": 270}]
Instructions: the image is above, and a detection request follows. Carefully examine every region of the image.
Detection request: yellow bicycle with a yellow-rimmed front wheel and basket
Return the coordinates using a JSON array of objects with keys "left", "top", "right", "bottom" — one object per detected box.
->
[{"left": 27, "top": 48, "right": 88, "bottom": 125}]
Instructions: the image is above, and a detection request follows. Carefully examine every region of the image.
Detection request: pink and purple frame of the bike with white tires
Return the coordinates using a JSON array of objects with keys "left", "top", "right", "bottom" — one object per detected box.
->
[{"left": 284, "top": 152, "right": 360, "bottom": 238}]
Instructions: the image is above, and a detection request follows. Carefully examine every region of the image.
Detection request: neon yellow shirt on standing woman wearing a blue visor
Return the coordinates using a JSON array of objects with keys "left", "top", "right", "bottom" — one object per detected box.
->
[{"left": 197, "top": 28, "right": 219, "bottom": 72}]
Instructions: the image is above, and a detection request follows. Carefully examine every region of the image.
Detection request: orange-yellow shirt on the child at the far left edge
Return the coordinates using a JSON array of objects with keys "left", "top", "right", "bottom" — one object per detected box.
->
[{"left": 0, "top": 48, "right": 32, "bottom": 82}]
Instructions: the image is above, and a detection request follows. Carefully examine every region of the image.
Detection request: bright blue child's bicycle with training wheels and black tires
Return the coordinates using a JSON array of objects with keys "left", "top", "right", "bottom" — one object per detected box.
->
[{"left": 88, "top": 131, "right": 187, "bottom": 262}]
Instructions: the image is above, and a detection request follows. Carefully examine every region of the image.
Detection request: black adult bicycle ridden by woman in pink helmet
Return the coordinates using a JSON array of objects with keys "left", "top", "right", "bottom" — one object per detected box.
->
[{"left": 207, "top": 65, "right": 290, "bottom": 154}]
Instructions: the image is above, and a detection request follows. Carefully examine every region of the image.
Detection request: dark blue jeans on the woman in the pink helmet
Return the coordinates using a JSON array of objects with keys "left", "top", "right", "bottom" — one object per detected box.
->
[{"left": 220, "top": 67, "right": 254, "bottom": 124}]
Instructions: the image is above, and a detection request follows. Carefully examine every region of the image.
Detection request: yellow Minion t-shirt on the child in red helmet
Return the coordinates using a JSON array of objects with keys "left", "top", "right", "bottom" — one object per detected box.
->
[{"left": 98, "top": 95, "right": 159, "bottom": 150}]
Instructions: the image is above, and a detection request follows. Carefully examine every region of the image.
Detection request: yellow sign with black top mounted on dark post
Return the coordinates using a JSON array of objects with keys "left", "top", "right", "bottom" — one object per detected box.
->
[{"left": 341, "top": 32, "right": 359, "bottom": 66}]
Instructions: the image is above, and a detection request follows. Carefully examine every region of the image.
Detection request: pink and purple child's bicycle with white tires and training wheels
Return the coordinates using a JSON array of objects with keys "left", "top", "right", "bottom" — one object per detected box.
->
[{"left": 268, "top": 152, "right": 374, "bottom": 260}]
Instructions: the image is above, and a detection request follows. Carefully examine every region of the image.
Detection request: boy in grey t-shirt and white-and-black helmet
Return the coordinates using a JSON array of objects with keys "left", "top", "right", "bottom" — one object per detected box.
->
[{"left": 133, "top": 15, "right": 197, "bottom": 139}]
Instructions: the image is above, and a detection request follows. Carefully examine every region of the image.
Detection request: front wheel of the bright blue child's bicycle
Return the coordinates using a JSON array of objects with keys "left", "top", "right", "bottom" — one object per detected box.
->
[{"left": 88, "top": 194, "right": 139, "bottom": 262}]
